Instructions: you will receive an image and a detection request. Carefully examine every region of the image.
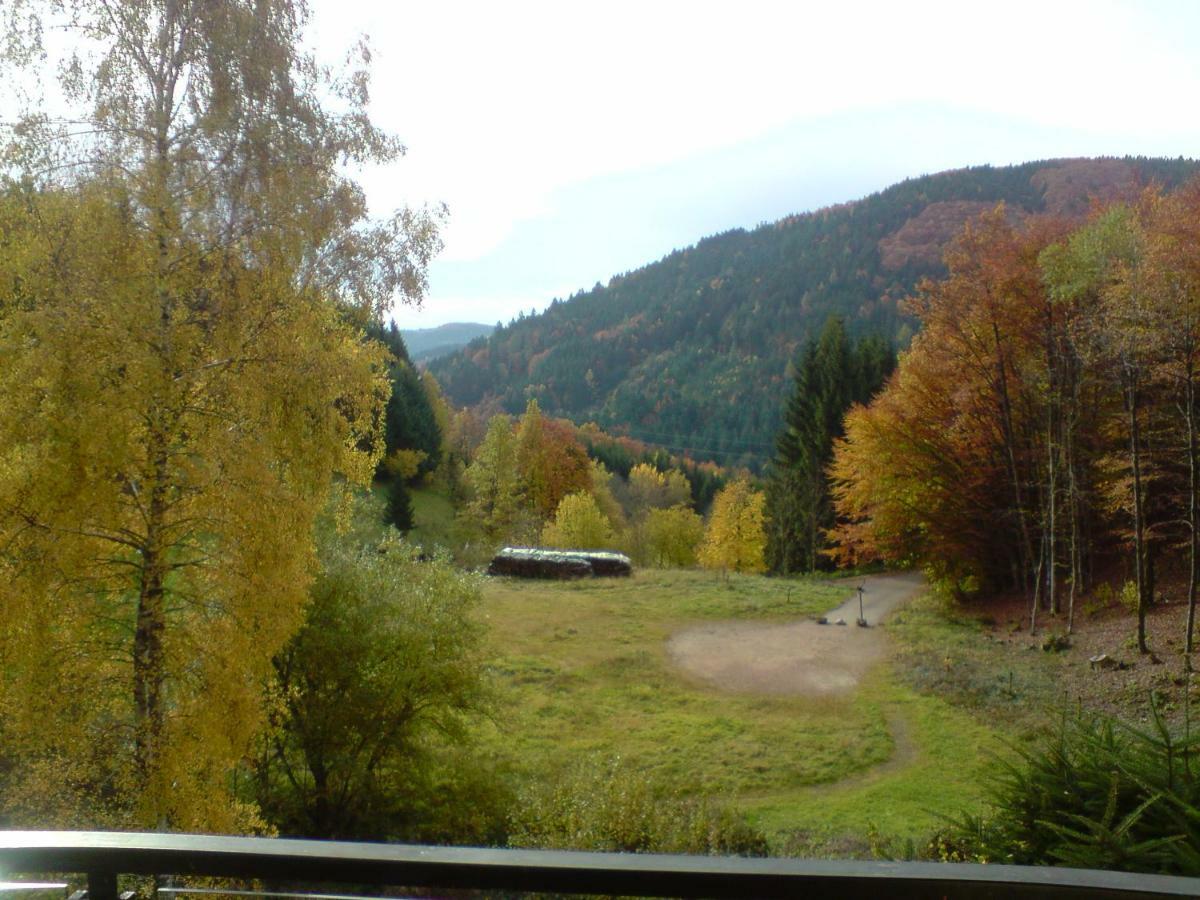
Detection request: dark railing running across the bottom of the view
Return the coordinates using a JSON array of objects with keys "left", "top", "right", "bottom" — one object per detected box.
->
[{"left": 0, "top": 832, "right": 1200, "bottom": 900}]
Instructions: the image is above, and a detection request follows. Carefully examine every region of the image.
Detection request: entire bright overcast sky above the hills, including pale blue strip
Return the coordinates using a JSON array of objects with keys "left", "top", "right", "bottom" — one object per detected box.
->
[{"left": 304, "top": 0, "right": 1200, "bottom": 328}]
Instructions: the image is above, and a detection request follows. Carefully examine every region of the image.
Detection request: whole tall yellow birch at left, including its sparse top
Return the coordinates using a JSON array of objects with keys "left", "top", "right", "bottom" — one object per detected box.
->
[{"left": 0, "top": 0, "right": 438, "bottom": 829}]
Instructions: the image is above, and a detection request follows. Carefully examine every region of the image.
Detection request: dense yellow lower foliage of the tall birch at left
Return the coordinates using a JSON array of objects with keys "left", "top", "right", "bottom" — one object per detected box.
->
[{"left": 0, "top": 188, "right": 388, "bottom": 830}]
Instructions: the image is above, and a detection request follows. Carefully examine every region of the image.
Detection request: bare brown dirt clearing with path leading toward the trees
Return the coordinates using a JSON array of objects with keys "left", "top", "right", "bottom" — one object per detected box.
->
[{"left": 667, "top": 574, "right": 925, "bottom": 696}]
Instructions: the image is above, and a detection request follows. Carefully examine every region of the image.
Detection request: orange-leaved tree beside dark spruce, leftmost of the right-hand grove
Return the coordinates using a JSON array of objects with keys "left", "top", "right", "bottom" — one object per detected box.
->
[{"left": 830, "top": 208, "right": 1075, "bottom": 598}]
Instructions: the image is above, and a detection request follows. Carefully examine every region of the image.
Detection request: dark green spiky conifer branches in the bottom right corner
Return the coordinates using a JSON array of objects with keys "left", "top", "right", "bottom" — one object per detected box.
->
[{"left": 935, "top": 707, "right": 1200, "bottom": 876}]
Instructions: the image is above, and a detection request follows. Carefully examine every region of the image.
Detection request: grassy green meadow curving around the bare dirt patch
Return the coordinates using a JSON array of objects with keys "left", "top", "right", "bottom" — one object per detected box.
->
[{"left": 472, "top": 570, "right": 1000, "bottom": 852}]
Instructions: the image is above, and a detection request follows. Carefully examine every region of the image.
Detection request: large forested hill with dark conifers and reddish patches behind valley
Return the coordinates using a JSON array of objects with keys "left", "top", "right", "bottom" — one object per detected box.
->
[{"left": 431, "top": 158, "right": 1200, "bottom": 468}]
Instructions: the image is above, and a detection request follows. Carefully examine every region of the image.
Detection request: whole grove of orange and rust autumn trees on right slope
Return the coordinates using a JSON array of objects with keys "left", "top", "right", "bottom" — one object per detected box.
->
[{"left": 832, "top": 181, "right": 1200, "bottom": 650}]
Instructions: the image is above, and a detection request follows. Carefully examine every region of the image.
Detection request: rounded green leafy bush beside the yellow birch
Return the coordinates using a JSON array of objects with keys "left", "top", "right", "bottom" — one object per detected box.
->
[{"left": 251, "top": 516, "right": 496, "bottom": 842}]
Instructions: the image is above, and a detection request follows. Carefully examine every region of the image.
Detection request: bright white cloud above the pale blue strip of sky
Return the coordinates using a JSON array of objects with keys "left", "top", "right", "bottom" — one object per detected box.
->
[{"left": 314, "top": 0, "right": 1200, "bottom": 271}]
